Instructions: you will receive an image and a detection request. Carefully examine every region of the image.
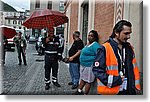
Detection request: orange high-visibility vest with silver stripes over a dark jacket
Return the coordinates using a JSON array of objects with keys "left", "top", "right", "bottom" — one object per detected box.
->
[{"left": 97, "top": 42, "right": 140, "bottom": 95}]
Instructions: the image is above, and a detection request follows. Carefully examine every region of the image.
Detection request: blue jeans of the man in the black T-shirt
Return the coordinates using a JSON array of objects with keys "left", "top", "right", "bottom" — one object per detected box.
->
[{"left": 69, "top": 63, "right": 80, "bottom": 84}]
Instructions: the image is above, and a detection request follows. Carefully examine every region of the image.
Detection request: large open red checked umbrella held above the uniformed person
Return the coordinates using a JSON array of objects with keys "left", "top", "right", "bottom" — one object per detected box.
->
[{"left": 23, "top": 9, "right": 68, "bottom": 29}]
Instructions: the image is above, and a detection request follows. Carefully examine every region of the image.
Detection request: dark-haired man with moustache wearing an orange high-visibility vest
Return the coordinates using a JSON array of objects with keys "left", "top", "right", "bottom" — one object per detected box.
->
[{"left": 93, "top": 20, "right": 140, "bottom": 95}]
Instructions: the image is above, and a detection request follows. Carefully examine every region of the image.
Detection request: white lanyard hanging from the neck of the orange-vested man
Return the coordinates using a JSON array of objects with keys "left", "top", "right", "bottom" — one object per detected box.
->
[{"left": 118, "top": 48, "right": 125, "bottom": 75}]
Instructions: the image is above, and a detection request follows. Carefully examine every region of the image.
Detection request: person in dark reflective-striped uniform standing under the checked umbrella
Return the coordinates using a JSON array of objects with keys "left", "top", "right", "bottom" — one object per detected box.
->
[{"left": 44, "top": 29, "right": 62, "bottom": 90}]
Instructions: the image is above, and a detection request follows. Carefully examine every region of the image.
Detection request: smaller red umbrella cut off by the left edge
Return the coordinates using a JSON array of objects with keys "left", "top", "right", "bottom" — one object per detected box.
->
[{"left": 0, "top": 25, "right": 17, "bottom": 39}]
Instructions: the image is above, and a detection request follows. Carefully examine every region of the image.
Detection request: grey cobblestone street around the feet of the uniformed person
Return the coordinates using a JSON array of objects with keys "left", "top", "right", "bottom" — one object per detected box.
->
[{"left": 2, "top": 44, "right": 83, "bottom": 95}]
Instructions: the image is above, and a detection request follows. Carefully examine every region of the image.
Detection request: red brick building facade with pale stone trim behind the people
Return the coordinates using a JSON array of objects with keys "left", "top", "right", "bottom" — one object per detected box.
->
[{"left": 64, "top": 0, "right": 143, "bottom": 72}]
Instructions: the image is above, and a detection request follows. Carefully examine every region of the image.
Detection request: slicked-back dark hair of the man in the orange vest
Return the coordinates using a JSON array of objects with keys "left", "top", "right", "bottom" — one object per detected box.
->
[{"left": 110, "top": 20, "right": 132, "bottom": 38}]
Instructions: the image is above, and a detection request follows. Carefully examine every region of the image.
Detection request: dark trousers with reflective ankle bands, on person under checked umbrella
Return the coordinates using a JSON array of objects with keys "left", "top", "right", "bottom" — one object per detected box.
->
[{"left": 45, "top": 54, "right": 58, "bottom": 83}]
